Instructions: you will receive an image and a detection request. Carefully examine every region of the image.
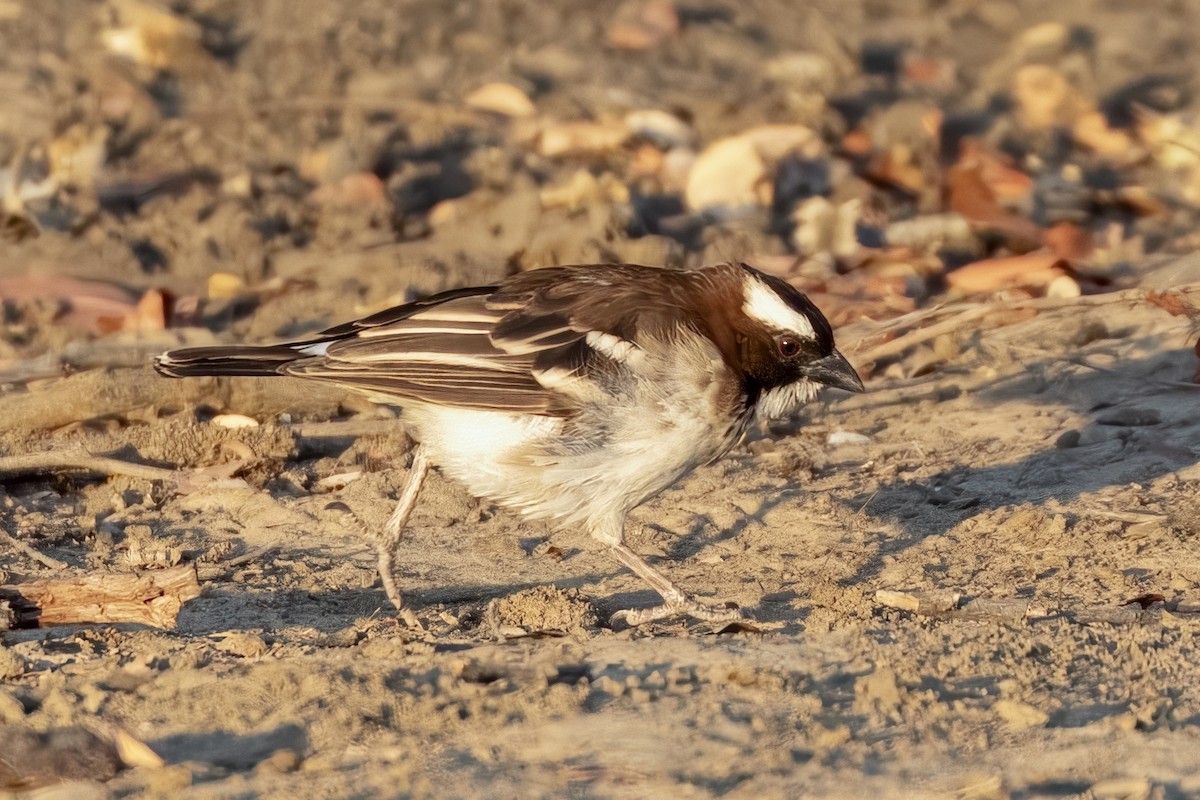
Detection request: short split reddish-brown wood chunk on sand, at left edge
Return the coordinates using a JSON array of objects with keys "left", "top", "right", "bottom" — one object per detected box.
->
[{"left": 0, "top": 564, "right": 200, "bottom": 628}]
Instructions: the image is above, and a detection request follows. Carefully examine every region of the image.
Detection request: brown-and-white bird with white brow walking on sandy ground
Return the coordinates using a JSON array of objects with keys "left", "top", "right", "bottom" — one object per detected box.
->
[{"left": 155, "top": 263, "right": 864, "bottom": 626}]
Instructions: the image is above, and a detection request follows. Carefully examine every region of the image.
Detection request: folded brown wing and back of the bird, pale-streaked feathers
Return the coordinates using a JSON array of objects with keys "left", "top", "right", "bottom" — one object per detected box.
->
[{"left": 282, "top": 265, "right": 710, "bottom": 416}]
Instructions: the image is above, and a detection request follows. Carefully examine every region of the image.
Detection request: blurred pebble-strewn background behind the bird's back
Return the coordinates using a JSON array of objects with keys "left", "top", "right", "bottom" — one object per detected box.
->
[{"left": 0, "top": 0, "right": 1200, "bottom": 367}]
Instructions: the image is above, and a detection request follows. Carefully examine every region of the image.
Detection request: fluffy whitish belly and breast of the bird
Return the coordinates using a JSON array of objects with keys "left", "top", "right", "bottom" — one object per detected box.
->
[{"left": 404, "top": 335, "right": 748, "bottom": 543}]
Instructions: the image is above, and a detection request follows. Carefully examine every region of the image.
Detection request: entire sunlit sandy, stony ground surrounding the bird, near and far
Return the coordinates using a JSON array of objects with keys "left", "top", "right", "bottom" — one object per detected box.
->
[{"left": 0, "top": 0, "right": 1200, "bottom": 800}]
